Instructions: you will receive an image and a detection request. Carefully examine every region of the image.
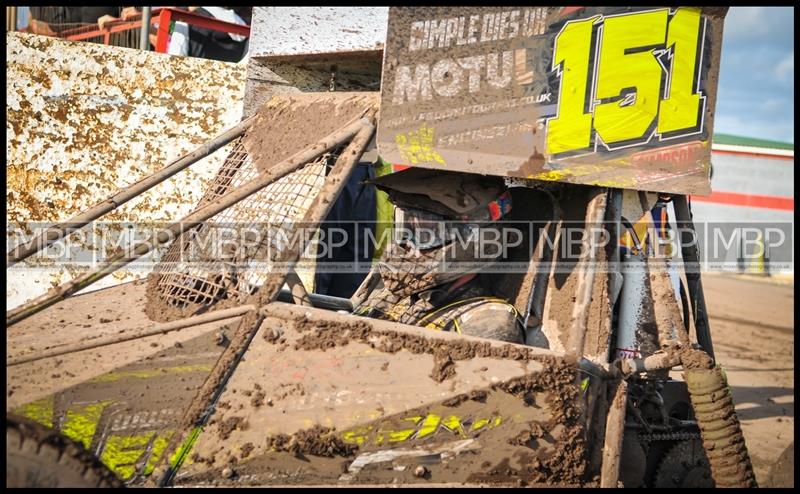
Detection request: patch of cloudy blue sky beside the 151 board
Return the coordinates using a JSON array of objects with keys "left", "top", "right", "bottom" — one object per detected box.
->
[{"left": 714, "top": 7, "right": 794, "bottom": 143}]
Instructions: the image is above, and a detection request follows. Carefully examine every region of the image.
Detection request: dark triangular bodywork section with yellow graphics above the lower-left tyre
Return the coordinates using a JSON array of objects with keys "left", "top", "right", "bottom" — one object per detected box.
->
[{"left": 9, "top": 331, "right": 227, "bottom": 485}]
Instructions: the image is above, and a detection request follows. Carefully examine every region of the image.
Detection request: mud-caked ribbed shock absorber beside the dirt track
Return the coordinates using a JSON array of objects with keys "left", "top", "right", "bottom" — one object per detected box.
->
[{"left": 681, "top": 349, "right": 757, "bottom": 487}]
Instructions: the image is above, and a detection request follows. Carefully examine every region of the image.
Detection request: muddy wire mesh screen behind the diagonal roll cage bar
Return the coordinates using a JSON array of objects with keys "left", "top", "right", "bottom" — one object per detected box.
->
[{"left": 147, "top": 140, "right": 339, "bottom": 321}]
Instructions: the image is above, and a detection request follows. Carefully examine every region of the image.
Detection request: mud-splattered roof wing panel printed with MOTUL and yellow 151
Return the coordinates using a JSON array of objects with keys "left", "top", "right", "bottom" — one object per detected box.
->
[{"left": 378, "top": 7, "right": 727, "bottom": 194}]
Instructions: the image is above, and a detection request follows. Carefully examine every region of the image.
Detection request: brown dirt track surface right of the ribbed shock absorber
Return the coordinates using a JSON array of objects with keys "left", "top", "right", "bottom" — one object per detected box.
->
[{"left": 692, "top": 275, "right": 794, "bottom": 487}]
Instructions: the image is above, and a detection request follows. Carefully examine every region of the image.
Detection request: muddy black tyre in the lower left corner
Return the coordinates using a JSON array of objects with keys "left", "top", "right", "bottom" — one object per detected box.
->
[{"left": 6, "top": 415, "right": 125, "bottom": 487}]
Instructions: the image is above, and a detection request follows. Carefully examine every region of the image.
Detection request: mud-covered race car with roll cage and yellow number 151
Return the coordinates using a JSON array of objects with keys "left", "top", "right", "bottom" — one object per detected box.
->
[{"left": 7, "top": 7, "right": 755, "bottom": 487}]
